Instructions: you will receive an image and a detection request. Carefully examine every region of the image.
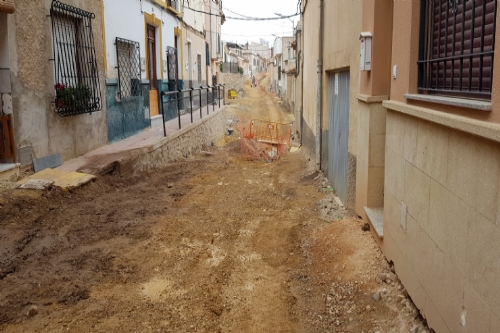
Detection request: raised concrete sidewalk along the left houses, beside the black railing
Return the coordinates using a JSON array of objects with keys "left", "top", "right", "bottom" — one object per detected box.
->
[{"left": 57, "top": 101, "right": 225, "bottom": 175}]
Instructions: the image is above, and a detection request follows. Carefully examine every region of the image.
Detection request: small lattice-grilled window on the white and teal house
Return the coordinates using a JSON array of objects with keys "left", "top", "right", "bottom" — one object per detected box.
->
[{"left": 115, "top": 37, "right": 141, "bottom": 98}]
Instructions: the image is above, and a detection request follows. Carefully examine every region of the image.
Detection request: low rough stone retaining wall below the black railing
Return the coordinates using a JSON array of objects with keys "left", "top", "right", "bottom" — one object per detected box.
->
[{"left": 115, "top": 109, "right": 226, "bottom": 175}]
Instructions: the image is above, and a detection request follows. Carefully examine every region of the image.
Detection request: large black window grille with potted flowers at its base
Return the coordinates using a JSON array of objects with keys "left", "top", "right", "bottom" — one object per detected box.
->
[{"left": 50, "top": 0, "right": 102, "bottom": 117}]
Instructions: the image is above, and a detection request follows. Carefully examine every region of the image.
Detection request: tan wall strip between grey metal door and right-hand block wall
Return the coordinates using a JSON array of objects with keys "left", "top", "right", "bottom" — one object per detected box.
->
[{"left": 356, "top": 0, "right": 393, "bottom": 221}]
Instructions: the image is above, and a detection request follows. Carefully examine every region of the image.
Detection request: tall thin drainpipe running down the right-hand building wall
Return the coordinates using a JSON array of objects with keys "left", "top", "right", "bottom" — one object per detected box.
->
[{"left": 316, "top": 0, "right": 325, "bottom": 170}]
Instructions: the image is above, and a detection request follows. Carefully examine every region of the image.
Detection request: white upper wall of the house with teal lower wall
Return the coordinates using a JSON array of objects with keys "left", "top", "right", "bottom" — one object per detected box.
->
[{"left": 104, "top": 0, "right": 180, "bottom": 79}]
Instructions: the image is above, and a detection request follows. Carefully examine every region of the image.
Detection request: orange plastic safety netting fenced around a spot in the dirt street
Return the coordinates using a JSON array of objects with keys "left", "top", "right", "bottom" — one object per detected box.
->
[{"left": 239, "top": 119, "right": 292, "bottom": 161}]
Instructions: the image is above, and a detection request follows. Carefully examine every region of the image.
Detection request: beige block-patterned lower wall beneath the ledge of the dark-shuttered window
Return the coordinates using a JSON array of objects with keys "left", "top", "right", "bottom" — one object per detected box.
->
[{"left": 382, "top": 109, "right": 500, "bottom": 333}]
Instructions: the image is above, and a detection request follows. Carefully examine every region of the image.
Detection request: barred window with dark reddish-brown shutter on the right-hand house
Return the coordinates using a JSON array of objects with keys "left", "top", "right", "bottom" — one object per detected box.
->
[{"left": 418, "top": 0, "right": 497, "bottom": 99}]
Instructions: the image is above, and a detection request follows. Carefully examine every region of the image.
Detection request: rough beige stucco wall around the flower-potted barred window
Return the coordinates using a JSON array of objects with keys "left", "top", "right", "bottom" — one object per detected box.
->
[{"left": 9, "top": 0, "right": 107, "bottom": 160}]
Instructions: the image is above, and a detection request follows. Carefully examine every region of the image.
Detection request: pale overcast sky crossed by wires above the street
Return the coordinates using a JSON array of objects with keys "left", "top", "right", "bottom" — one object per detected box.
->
[{"left": 218, "top": 0, "right": 300, "bottom": 45}]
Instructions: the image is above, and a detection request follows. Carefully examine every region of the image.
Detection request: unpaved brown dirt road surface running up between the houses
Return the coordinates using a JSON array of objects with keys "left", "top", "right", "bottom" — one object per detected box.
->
[{"left": 0, "top": 74, "right": 427, "bottom": 333}]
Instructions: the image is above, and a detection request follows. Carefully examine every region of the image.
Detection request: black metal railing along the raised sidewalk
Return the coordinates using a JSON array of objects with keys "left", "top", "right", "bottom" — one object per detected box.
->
[{"left": 160, "top": 84, "right": 225, "bottom": 136}]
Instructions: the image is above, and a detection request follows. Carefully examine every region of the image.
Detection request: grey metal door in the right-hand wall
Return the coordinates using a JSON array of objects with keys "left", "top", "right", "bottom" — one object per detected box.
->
[{"left": 328, "top": 71, "right": 349, "bottom": 205}]
